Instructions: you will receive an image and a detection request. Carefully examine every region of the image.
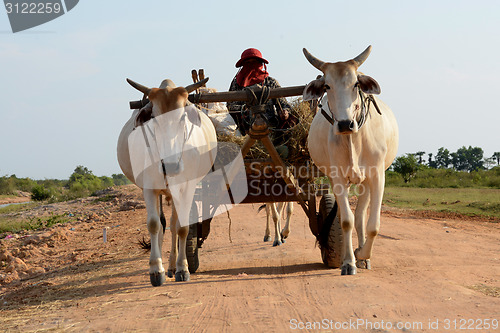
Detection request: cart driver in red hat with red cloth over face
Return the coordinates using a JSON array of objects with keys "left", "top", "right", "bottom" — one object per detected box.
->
[{"left": 227, "top": 48, "right": 294, "bottom": 144}]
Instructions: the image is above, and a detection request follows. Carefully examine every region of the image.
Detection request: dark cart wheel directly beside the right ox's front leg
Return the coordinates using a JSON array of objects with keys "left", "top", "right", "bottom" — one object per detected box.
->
[{"left": 318, "top": 194, "right": 343, "bottom": 268}]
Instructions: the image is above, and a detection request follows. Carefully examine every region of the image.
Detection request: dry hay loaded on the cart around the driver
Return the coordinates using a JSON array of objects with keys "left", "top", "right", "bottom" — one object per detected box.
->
[{"left": 217, "top": 98, "right": 314, "bottom": 164}]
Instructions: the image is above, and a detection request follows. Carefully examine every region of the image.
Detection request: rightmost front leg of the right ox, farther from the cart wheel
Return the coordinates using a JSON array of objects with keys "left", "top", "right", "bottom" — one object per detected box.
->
[{"left": 356, "top": 172, "right": 385, "bottom": 260}]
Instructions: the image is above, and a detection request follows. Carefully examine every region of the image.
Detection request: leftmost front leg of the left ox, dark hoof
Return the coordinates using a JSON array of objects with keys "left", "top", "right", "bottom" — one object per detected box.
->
[{"left": 143, "top": 190, "right": 165, "bottom": 287}]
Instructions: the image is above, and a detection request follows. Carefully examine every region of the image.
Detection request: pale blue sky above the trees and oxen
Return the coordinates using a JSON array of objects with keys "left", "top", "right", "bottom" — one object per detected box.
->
[{"left": 0, "top": 0, "right": 500, "bottom": 179}]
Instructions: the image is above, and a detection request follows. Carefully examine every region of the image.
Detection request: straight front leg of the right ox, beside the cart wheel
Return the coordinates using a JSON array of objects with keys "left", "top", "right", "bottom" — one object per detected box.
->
[{"left": 331, "top": 181, "right": 356, "bottom": 275}]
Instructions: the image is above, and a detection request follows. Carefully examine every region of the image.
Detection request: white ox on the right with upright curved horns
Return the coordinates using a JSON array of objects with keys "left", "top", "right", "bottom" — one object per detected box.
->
[{"left": 303, "top": 46, "right": 399, "bottom": 275}]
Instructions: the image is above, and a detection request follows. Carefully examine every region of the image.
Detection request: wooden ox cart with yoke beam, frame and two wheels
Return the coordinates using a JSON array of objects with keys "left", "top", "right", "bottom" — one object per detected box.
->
[{"left": 130, "top": 79, "right": 342, "bottom": 273}]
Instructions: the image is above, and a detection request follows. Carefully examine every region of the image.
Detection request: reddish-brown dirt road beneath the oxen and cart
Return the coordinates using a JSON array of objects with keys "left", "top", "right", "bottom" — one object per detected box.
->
[{"left": 0, "top": 185, "right": 500, "bottom": 332}]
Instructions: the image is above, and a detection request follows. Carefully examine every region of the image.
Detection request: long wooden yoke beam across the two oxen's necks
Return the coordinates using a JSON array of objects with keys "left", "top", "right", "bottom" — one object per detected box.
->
[{"left": 130, "top": 85, "right": 306, "bottom": 109}]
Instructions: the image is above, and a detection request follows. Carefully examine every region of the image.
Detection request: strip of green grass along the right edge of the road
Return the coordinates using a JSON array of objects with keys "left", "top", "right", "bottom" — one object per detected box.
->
[{"left": 383, "top": 186, "right": 500, "bottom": 222}]
